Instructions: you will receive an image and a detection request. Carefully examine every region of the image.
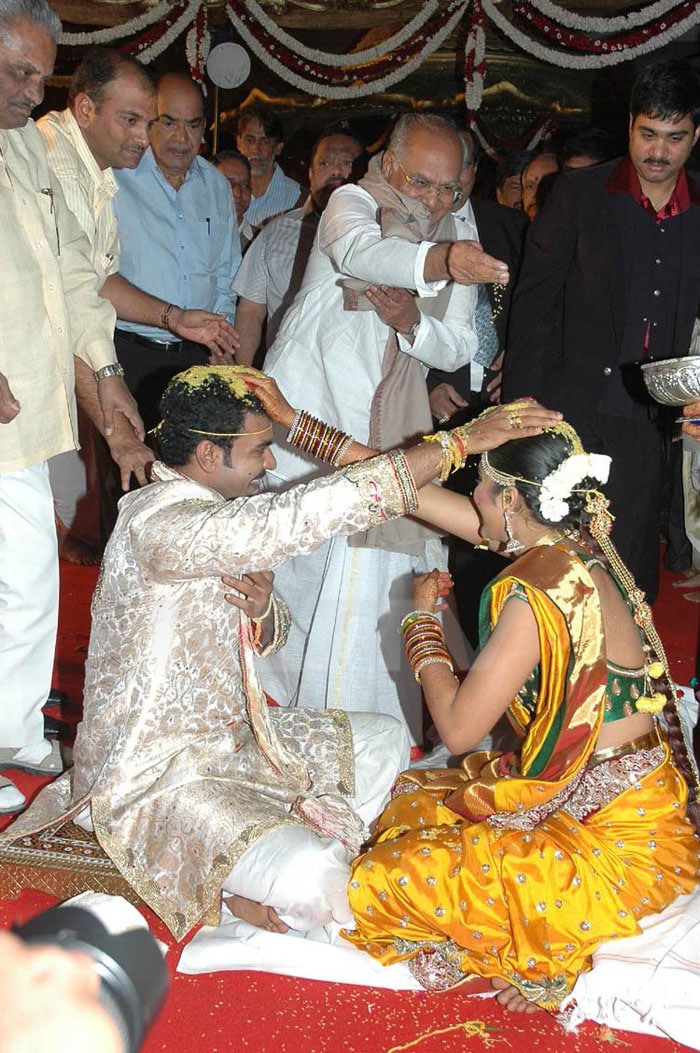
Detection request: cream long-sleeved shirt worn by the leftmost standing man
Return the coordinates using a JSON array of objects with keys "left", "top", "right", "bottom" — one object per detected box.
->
[{"left": 0, "top": 121, "right": 116, "bottom": 472}]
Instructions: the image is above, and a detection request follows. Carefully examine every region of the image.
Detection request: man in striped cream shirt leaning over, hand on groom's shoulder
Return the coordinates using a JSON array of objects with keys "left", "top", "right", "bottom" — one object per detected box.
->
[{"left": 37, "top": 47, "right": 234, "bottom": 547}]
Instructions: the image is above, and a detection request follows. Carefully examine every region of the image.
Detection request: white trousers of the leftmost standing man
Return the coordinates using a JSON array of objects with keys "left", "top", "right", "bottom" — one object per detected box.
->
[{"left": 0, "top": 461, "right": 58, "bottom": 749}]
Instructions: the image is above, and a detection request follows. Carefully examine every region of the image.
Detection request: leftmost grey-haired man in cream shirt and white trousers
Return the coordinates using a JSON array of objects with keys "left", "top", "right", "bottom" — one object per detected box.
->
[{"left": 0, "top": 0, "right": 140, "bottom": 813}]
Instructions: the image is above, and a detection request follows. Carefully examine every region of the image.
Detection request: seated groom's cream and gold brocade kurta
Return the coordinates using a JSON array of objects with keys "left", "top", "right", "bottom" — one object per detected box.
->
[{"left": 4, "top": 454, "right": 415, "bottom": 939}]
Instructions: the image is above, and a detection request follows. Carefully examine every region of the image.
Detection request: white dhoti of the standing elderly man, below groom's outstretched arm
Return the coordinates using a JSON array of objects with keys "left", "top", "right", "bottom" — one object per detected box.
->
[{"left": 259, "top": 537, "right": 468, "bottom": 746}]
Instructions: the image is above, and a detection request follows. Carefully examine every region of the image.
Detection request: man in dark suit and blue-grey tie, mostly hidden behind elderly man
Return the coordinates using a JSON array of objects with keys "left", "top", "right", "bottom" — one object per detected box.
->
[{"left": 427, "top": 131, "right": 527, "bottom": 648}]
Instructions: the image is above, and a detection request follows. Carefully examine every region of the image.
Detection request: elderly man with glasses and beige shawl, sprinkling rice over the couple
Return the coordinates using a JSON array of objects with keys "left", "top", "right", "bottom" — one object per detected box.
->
[{"left": 264, "top": 115, "right": 508, "bottom": 746}]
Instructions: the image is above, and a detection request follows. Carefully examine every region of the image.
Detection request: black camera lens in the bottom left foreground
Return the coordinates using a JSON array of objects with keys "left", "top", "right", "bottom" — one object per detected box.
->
[{"left": 14, "top": 906, "right": 167, "bottom": 1053}]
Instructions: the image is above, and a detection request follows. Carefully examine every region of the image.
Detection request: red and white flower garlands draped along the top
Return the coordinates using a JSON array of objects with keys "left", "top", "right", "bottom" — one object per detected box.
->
[{"left": 60, "top": 0, "right": 700, "bottom": 91}]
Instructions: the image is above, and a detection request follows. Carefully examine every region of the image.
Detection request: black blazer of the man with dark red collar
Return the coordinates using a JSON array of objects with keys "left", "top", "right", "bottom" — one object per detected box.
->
[{"left": 503, "top": 159, "right": 700, "bottom": 423}]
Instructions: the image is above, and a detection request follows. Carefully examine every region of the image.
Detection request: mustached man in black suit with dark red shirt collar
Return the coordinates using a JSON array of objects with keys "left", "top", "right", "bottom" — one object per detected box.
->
[{"left": 503, "top": 61, "right": 700, "bottom": 601}]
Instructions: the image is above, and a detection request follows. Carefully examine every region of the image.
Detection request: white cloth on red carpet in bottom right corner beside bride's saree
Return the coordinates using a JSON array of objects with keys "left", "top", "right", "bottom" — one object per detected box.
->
[{"left": 566, "top": 888, "right": 700, "bottom": 1050}]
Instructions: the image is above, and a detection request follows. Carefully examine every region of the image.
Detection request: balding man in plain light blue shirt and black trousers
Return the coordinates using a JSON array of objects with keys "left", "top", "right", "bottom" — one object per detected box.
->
[{"left": 115, "top": 74, "right": 241, "bottom": 428}]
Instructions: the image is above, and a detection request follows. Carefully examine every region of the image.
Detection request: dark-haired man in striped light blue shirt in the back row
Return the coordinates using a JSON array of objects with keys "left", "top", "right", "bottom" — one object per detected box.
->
[{"left": 238, "top": 103, "right": 306, "bottom": 229}]
